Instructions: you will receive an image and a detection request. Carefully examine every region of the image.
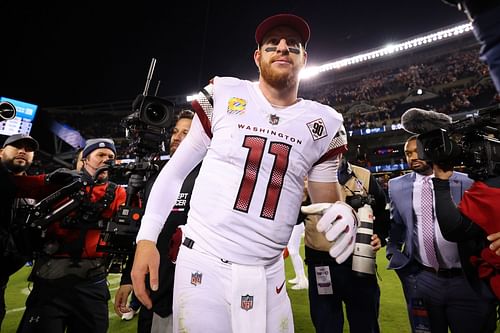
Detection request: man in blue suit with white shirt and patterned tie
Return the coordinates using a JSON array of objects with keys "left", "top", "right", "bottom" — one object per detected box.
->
[{"left": 387, "top": 136, "right": 495, "bottom": 333}]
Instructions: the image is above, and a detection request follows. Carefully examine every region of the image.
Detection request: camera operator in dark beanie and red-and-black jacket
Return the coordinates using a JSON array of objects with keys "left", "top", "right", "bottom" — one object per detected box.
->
[{"left": 11, "top": 138, "right": 126, "bottom": 333}]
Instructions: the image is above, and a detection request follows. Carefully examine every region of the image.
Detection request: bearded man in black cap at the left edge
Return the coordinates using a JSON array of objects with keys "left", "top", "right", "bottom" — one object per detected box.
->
[{"left": 0, "top": 134, "right": 38, "bottom": 327}]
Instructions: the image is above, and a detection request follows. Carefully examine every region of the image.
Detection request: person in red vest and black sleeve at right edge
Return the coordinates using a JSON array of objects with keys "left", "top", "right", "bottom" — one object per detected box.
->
[{"left": 433, "top": 160, "right": 500, "bottom": 299}]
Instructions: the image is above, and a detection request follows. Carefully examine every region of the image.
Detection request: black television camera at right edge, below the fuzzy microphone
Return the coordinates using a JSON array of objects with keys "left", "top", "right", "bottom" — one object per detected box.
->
[{"left": 416, "top": 105, "right": 500, "bottom": 180}]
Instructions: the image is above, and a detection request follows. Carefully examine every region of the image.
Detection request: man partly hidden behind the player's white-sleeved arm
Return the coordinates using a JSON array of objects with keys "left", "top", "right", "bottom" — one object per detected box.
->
[{"left": 115, "top": 110, "right": 197, "bottom": 333}]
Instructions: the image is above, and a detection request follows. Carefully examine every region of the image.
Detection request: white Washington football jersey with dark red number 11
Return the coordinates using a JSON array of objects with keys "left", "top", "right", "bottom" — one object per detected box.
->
[{"left": 184, "top": 77, "right": 347, "bottom": 265}]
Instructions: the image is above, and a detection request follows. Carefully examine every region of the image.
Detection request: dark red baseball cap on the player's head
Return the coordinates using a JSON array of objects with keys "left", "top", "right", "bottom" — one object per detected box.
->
[{"left": 255, "top": 14, "right": 311, "bottom": 47}]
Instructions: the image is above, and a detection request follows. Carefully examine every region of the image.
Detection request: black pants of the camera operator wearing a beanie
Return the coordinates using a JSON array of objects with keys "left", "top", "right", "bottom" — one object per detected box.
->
[{"left": 17, "top": 279, "right": 110, "bottom": 333}]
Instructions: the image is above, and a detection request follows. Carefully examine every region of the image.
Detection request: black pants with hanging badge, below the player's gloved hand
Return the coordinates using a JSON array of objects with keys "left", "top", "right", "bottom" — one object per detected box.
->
[{"left": 306, "top": 253, "right": 380, "bottom": 333}]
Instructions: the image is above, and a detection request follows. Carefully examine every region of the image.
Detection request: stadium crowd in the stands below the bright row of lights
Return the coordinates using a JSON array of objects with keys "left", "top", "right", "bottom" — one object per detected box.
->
[{"left": 305, "top": 48, "right": 500, "bottom": 129}]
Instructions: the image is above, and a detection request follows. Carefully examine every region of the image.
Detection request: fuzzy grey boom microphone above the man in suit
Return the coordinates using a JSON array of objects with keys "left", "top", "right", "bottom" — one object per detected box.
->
[{"left": 401, "top": 108, "right": 452, "bottom": 134}]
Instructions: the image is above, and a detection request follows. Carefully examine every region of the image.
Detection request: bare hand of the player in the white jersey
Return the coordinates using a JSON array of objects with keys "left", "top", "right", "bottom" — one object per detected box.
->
[{"left": 131, "top": 240, "right": 160, "bottom": 309}]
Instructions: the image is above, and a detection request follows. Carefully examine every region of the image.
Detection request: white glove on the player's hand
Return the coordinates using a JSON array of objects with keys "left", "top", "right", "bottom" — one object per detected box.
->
[{"left": 301, "top": 201, "right": 358, "bottom": 264}]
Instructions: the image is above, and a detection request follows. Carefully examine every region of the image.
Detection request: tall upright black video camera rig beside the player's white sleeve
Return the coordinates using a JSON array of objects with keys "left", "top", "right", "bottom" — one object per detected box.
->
[{"left": 97, "top": 58, "right": 176, "bottom": 272}]
